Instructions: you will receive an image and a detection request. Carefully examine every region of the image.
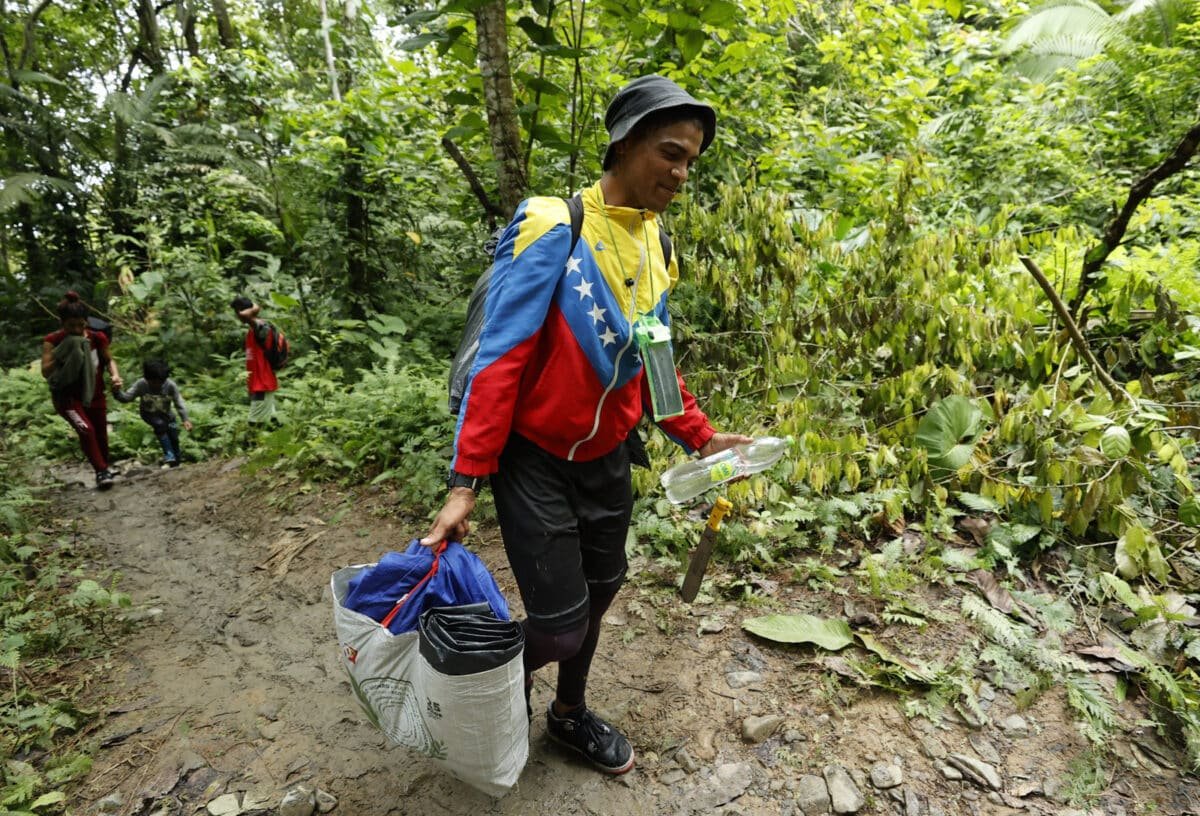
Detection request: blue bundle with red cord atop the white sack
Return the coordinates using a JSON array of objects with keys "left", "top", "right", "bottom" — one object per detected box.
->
[{"left": 342, "top": 539, "right": 510, "bottom": 635}]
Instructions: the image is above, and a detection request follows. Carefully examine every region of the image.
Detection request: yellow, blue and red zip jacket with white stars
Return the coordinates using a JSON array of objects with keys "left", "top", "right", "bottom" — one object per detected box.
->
[{"left": 451, "top": 182, "right": 714, "bottom": 476}]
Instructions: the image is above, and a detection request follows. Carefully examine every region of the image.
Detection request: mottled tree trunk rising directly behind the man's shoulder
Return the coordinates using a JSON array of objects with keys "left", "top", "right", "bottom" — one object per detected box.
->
[{"left": 475, "top": 0, "right": 528, "bottom": 217}]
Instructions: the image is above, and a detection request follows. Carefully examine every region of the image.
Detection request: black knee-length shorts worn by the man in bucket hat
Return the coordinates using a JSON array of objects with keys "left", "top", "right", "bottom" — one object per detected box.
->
[{"left": 491, "top": 434, "right": 634, "bottom": 634}]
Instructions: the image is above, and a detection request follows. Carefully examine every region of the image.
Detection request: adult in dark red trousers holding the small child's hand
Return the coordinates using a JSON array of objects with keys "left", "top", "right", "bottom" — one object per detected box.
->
[{"left": 42, "top": 292, "right": 121, "bottom": 490}]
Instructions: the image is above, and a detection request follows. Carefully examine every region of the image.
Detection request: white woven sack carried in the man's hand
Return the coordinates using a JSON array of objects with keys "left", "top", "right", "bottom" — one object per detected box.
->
[{"left": 330, "top": 564, "right": 529, "bottom": 797}]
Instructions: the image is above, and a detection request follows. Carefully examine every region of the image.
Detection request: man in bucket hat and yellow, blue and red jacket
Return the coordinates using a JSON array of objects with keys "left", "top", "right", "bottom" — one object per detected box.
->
[{"left": 421, "top": 76, "right": 751, "bottom": 774}]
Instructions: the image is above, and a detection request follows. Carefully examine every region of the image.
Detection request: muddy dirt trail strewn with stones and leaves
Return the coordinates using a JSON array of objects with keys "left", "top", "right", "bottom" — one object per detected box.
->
[{"left": 59, "top": 463, "right": 1200, "bottom": 816}]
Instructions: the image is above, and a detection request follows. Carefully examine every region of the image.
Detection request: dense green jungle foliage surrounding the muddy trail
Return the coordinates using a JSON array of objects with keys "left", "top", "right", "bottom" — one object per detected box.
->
[{"left": 0, "top": 0, "right": 1200, "bottom": 812}]
